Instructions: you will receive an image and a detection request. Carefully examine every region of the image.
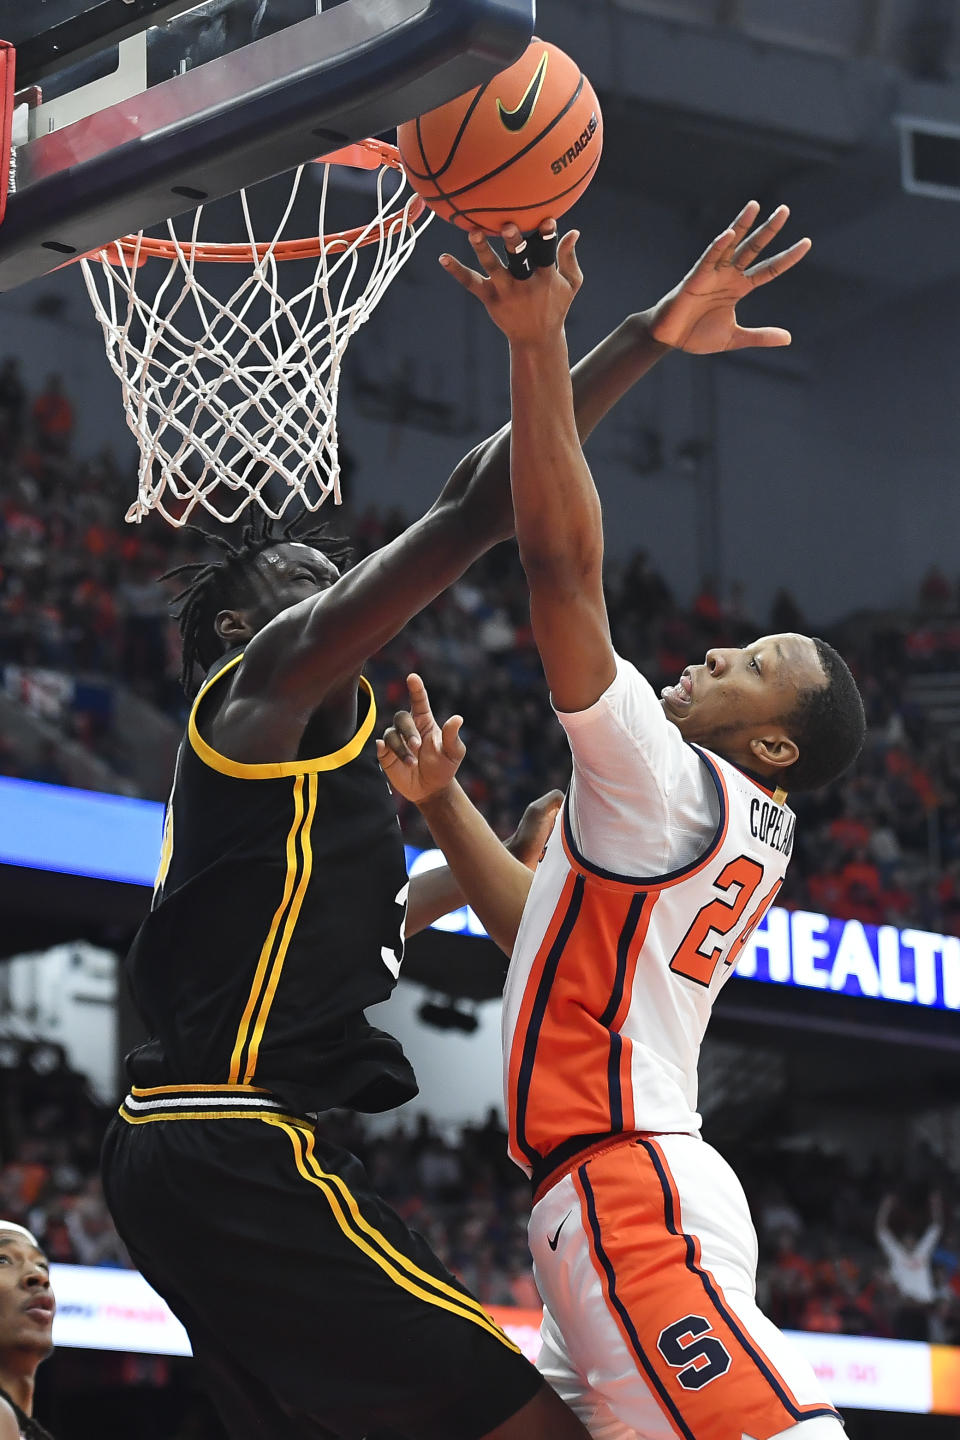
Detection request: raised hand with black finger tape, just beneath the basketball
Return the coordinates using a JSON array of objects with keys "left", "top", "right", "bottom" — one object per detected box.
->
[{"left": 440, "top": 220, "right": 583, "bottom": 346}]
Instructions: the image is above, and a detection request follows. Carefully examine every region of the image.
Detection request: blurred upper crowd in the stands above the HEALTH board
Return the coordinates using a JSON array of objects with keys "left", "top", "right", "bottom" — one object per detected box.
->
[{"left": 0, "top": 360, "right": 960, "bottom": 933}]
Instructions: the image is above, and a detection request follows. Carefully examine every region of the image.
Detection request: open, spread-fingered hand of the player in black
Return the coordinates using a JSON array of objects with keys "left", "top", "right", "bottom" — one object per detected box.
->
[{"left": 645, "top": 200, "right": 810, "bottom": 356}]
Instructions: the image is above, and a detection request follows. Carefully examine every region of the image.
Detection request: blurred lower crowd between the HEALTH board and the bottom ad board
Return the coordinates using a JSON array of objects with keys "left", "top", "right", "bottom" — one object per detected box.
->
[{"left": 0, "top": 1043, "right": 960, "bottom": 1345}]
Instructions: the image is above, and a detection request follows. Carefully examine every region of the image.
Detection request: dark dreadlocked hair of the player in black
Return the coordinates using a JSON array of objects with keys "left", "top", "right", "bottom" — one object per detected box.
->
[{"left": 160, "top": 513, "right": 353, "bottom": 697}]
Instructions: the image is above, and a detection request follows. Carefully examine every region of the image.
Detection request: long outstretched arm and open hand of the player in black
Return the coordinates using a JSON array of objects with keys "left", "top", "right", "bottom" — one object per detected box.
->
[{"left": 233, "top": 202, "right": 809, "bottom": 737}]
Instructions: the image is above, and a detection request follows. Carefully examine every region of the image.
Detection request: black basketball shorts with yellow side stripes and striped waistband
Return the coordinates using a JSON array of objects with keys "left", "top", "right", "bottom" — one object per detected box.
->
[{"left": 104, "top": 1086, "right": 543, "bottom": 1440}]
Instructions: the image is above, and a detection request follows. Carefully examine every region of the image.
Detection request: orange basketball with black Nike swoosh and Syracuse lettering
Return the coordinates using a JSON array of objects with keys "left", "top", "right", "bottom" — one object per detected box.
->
[{"left": 397, "top": 37, "right": 603, "bottom": 235}]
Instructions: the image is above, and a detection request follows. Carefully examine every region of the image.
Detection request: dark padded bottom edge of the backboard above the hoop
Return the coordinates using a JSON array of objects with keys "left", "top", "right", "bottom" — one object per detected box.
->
[{"left": 0, "top": 0, "right": 534, "bottom": 289}]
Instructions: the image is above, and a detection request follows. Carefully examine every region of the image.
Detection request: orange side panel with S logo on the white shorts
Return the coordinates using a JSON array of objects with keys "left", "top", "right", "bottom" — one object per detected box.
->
[{"left": 573, "top": 1138, "right": 836, "bottom": 1440}]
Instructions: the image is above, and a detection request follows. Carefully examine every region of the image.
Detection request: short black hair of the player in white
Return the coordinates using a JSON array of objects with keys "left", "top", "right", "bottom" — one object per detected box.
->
[{"left": 777, "top": 636, "right": 866, "bottom": 791}]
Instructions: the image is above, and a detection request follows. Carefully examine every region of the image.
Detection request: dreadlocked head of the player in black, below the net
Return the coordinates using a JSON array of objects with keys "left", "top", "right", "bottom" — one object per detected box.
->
[{"left": 161, "top": 520, "right": 351, "bottom": 694}]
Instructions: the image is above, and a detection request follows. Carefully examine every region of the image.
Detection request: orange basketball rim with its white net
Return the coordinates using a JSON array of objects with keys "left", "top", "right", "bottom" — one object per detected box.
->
[{"left": 81, "top": 140, "right": 433, "bottom": 526}]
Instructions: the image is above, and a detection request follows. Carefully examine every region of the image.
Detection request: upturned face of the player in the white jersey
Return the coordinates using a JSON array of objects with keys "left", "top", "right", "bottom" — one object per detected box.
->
[{"left": 661, "top": 635, "right": 826, "bottom": 765}]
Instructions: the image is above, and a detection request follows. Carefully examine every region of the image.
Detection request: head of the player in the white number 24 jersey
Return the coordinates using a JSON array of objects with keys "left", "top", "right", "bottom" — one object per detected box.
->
[{"left": 661, "top": 632, "right": 866, "bottom": 791}]
